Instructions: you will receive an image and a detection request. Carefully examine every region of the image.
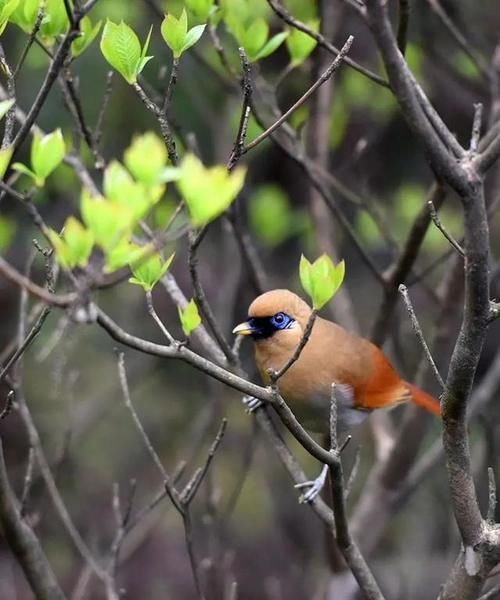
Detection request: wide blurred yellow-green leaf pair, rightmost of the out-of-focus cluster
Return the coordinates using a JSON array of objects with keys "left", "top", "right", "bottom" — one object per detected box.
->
[{"left": 176, "top": 154, "right": 246, "bottom": 227}]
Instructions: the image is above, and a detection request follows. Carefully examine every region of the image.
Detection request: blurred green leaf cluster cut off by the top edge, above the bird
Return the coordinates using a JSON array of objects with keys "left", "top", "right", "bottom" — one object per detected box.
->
[{"left": 222, "top": 0, "right": 288, "bottom": 62}]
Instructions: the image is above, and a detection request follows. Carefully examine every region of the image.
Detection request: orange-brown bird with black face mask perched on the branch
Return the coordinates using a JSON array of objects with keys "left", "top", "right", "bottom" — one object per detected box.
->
[{"left": 233, "top": 290, "right": 440, "bottom": 433}]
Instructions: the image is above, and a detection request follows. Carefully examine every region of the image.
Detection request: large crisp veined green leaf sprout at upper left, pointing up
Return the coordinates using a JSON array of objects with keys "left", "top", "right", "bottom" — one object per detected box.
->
[{"left": 101, "top": 19, "right": 153, "bottom": 84}]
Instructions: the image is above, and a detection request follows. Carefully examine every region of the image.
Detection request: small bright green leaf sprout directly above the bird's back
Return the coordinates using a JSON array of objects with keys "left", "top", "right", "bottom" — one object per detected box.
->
[{"left": 299, "top": 254, "right": 345, "bottom": 310}]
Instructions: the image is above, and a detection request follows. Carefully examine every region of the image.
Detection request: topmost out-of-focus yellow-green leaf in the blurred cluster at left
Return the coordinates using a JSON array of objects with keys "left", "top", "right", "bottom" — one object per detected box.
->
[{"left": 123, "top": 132, "right": 167, "bottom": 186}]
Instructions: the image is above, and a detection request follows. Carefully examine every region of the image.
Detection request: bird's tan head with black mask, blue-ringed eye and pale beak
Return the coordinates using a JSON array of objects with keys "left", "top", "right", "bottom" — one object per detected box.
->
[{"left": 233, "top": 290, "right": 311, "bottom": 344}]
